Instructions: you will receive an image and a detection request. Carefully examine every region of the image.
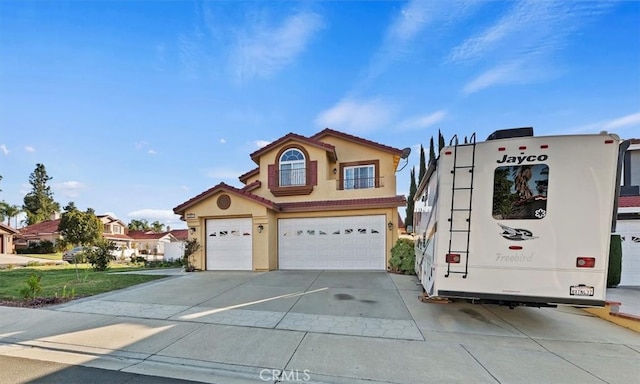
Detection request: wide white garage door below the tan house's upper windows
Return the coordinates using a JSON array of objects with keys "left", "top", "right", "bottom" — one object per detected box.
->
[{"left": 278, "top": 215, "right": 386, "bottom": 270}]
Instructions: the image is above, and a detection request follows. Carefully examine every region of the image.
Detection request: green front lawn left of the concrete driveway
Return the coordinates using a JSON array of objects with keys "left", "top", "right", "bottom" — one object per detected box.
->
[{"left": 0, "top": 265, "right": 165, "bottom": 301}]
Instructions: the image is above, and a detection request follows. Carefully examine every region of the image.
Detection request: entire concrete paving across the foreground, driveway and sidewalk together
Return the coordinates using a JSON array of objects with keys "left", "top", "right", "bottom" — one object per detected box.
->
[{"left": 0, "top": 271, "right": 640, "bottom": 384}]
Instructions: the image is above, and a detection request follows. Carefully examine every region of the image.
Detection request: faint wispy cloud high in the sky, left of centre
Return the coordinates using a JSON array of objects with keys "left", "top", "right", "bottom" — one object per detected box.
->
[{"left": 230, "top": 11, "right": 323, "bottom": 80}]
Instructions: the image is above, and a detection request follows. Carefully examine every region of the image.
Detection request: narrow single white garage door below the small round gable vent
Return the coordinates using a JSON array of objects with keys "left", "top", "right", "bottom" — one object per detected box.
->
[{"left": 206, "top": 219, "right": 253, "bottom": 271}]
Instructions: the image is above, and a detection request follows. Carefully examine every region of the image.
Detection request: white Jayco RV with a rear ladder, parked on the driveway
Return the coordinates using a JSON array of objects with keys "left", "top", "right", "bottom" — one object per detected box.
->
[{"left": 414, "top": 128, "right": 628, "bottom": 307}]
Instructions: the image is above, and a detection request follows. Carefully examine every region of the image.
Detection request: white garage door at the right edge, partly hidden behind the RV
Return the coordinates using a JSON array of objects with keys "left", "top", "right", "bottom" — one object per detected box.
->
[{"left": 616, "top": 220, "right": 640, "bottom": 285}]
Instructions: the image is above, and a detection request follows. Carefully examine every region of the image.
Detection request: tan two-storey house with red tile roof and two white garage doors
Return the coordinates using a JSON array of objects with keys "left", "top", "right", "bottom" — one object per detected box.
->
[{"left": 174, "top": 129, "right": 406, "bottom": 270}]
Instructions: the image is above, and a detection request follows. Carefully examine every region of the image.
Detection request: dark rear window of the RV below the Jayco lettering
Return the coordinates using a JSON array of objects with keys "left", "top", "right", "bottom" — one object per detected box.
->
[{"left": 493, "top": 164, "right": 549, "bottom": 220}]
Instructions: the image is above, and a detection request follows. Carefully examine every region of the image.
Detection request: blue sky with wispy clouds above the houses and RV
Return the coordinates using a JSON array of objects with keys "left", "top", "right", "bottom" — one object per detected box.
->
[{"left": 0, "top": 0, "right": 640, "bottom": 228}]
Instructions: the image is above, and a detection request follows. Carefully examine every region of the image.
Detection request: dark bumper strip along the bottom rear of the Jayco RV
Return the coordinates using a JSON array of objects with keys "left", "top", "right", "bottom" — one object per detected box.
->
[{"left": 438, "top": 290, "right": 605, "bottom": 307}]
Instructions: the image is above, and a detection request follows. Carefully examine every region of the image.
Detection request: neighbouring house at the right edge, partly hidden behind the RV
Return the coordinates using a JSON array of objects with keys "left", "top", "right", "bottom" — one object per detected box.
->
[{"left": 616, "top": 139, "right": 640, "bottom": 286}]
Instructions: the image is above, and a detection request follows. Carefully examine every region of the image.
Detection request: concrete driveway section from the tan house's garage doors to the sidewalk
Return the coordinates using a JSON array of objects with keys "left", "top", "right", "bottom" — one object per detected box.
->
[{"left": 58, "top": 271, "right": 423, "bottom": 340}]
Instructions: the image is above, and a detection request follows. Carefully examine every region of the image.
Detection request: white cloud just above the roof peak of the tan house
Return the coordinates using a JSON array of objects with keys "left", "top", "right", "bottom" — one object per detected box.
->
[{"left": 315, "top": 99, "right": 395, "bottom": 133}]
